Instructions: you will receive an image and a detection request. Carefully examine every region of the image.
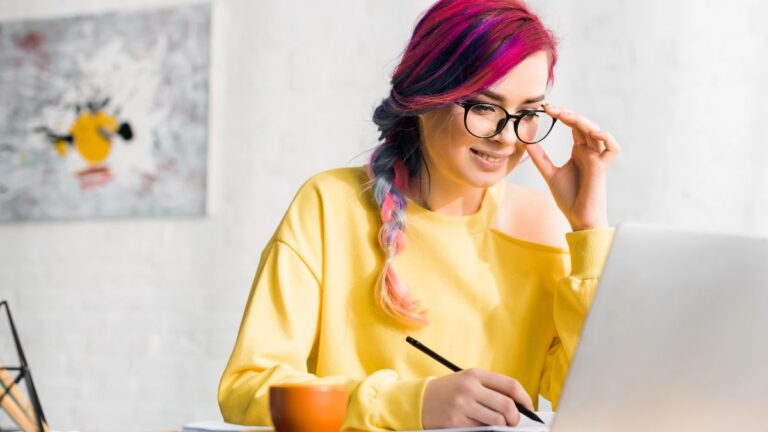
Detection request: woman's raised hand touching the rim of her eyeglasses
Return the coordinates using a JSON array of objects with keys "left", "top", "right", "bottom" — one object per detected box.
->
[{"left": 526, "top": 105, "right": 620, "bottom": 231}]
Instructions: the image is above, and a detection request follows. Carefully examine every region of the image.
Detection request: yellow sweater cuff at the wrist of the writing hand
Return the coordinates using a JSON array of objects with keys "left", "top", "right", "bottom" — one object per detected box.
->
[{"left": 376, "top": 377, "right": 434, "bottom": 430}]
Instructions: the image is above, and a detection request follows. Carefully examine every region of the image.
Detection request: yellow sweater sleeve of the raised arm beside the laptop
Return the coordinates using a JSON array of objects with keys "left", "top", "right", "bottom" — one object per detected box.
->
[{"left": 540, "top": 228, "right": 615, "bottom": 409}]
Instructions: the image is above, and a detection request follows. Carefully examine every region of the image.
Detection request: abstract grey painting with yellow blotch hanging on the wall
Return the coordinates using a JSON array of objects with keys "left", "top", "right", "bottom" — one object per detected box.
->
[{"left": 0, "top": 3, "right": 211, "bottom": 222}]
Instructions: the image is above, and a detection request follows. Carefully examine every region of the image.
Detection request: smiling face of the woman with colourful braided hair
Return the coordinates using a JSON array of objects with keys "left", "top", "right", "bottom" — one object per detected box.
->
[{"left": 419, "top": 51, "right": 549, "bottom": 189}]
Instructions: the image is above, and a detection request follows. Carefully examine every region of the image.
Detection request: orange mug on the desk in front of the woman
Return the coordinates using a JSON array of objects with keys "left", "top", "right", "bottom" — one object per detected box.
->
[{"left": 269, "top": 384, "right": 348, "bottom": 432}]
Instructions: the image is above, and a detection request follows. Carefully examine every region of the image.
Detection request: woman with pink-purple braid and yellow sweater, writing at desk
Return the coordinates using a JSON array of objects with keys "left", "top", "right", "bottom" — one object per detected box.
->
[{"left": 219, "top": 0, "right": 619, "bottom": 430}]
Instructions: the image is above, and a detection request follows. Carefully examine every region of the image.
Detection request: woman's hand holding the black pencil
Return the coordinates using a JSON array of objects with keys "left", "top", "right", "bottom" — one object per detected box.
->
[{"left": 421, "top": 369, "right": 533, "bottom": 429}]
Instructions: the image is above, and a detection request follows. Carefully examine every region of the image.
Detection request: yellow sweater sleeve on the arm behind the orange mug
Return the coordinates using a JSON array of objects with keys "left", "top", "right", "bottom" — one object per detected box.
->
[{"left": 218, "top": 171, "right": 430, "bottom": 430}]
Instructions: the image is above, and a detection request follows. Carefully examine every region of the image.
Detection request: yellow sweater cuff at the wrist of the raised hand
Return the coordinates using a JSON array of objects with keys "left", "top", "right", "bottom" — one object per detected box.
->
[{"left": 565, "top": 228, "right": 616, "bottom": 279}]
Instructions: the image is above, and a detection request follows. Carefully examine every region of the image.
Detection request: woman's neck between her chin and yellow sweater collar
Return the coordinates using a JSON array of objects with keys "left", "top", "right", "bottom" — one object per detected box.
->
[{"left": 408, "top": 170, "right": 484, "bottom": 216}]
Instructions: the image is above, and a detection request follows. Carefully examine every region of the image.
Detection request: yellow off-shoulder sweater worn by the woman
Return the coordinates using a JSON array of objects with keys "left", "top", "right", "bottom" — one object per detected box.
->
[{"left": 218, "top": 168, "right": 613, "bottom": 430}]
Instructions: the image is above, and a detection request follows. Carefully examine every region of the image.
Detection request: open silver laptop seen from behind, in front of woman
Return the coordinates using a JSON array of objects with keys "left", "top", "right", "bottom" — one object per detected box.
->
[{"left": 416, "top": 223, "right": 768, "bottom": 432}]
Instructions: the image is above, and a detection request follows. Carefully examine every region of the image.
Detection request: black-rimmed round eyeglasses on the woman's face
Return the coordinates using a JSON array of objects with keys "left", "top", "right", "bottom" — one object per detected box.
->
[{"left": 456, "top": 101, "right": 557, "bottom": 144}]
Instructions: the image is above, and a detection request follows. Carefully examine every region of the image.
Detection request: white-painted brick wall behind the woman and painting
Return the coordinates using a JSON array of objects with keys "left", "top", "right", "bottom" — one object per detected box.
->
[{"left": 0, "top": 0, "right": 768, "bottom": 431}]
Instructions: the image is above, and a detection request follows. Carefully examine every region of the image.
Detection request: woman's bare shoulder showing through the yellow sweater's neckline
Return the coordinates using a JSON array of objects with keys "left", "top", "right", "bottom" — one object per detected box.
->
[{"left": 495, "top": 182, "right": 571, "bottom": 248}]
